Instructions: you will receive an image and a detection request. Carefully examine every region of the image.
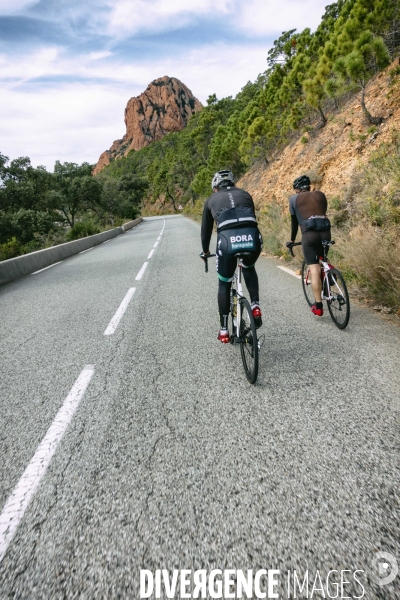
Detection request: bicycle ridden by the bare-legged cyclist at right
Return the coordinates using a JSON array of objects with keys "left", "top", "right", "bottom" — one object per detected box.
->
[{"left": 286, "top": 240, "right": 350, "bottom": 329}]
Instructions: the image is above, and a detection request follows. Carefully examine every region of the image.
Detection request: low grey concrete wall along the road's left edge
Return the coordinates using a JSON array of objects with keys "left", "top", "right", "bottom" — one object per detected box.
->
[{"left": 0, "top": 217, "right": 143, "bottom": 285}]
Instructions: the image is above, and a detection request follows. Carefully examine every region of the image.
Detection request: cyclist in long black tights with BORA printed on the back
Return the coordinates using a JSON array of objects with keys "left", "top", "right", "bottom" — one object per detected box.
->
[{"left": 201, "top": 171, "right": 262, "bottom": 344}]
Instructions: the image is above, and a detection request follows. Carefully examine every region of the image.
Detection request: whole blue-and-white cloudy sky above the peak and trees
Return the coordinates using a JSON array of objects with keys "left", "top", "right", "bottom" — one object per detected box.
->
[{"left": 0, "top": 0, "right": 330, "bottom": 171}]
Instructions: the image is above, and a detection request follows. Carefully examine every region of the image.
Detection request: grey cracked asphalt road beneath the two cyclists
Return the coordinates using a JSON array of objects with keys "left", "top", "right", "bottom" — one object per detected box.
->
[{"left": 0, "top": 216, "right": 400, "bottom": 600}]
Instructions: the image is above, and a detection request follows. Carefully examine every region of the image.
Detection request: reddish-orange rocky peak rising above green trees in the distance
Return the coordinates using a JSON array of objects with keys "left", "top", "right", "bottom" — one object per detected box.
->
[{"left": 93, "top": 76, "right": 202, "bottom": 174}]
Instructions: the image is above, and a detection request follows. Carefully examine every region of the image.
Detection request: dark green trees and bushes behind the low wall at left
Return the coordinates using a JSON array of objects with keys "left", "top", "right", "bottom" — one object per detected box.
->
[{"left": 0, "top": 155, "right": 147, "bottom": 260}]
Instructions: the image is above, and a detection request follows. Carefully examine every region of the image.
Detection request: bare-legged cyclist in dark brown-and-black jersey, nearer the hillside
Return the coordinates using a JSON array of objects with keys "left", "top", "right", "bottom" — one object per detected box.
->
[{"left": 288, "top": 175, "right": 331, "bottom": 317}]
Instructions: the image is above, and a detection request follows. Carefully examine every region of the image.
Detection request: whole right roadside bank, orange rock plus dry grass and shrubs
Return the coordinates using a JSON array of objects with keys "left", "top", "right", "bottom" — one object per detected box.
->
[{"left": 238, "top": 59, "right": 400, "bottom": 324}]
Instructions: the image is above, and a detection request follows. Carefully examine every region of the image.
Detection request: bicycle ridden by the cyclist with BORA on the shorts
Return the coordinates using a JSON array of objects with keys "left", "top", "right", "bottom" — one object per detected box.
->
[{"left": 200, "top": 253, "right": 262, "bottom": 383}]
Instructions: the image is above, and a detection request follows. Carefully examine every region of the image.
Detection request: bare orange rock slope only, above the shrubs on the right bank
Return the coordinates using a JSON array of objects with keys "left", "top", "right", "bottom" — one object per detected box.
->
[{"left": 238, "top": 59, "right": 400, "bottom": 208}]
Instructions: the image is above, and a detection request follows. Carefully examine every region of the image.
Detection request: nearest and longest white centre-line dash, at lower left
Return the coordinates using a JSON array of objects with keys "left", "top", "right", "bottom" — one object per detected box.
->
[{"left": 0, "top": 365, "right": 94, "bottom": 562}]
